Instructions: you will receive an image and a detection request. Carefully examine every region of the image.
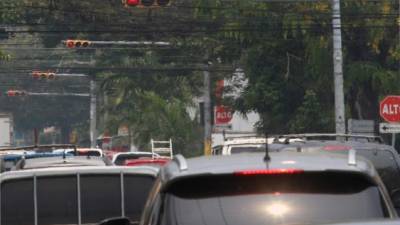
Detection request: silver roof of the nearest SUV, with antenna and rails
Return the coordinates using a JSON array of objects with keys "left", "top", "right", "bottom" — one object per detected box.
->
[{"left": 161, "top": 152, "right": 377, "bottom": 180}]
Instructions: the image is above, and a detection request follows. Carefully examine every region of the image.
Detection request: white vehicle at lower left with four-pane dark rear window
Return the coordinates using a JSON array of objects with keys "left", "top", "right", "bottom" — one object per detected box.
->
[{"left": 0, "top": 166, "right": 158, "bottom": 225}]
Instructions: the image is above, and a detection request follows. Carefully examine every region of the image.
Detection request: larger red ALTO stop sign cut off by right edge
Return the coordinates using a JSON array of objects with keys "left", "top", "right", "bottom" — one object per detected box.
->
[{"left": 379, "top": 96, "right": 400, "bottom": 122}]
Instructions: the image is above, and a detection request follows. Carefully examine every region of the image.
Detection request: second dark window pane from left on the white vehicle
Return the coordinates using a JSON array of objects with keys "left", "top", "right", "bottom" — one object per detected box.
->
[{"left": 37, "top": 176, "right": 78, "bottom": 225}]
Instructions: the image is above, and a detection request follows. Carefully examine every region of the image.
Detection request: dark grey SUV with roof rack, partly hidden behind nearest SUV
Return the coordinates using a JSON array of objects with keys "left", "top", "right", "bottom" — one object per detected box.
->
[{"left": 274, "top": 134, "right": 400, "bottom": 210}]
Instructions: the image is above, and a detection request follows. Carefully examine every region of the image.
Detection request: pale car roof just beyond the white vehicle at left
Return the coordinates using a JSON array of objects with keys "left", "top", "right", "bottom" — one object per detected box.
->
[{"left": 16, "top": 156, "right": 106, "bottom": 169}]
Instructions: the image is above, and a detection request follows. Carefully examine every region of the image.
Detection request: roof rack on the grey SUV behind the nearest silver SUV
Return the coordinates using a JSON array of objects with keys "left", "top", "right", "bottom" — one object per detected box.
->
[{"left": 274, "top": 133, "right": 383, "bottom": 144}]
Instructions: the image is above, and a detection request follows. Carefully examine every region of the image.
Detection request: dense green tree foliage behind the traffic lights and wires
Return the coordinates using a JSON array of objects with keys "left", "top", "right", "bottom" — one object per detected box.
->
[{"left": 0, "top": 0, "right": 400, "bottom": 149}]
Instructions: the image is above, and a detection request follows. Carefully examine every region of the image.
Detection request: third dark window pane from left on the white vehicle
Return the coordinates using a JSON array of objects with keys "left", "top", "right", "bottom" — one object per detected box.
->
[{"left": 81, "top": 174, "right": 122, "bottom": 223}]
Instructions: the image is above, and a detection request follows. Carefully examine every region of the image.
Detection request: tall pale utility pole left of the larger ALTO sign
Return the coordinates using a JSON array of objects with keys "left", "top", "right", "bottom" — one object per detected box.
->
[{"left": 332, "top": 0, "right": 346, "bottom": 134}]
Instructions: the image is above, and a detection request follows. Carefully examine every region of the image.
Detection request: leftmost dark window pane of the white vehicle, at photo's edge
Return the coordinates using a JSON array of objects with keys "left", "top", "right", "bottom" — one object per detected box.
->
[{"left": 1, "top": 179, "right": 34, "bottom": 225}]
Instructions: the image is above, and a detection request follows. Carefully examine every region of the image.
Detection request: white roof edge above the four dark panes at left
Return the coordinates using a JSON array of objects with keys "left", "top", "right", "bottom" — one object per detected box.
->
[{"left": 0, "top": 166, "right": 159, "bottom": 182}]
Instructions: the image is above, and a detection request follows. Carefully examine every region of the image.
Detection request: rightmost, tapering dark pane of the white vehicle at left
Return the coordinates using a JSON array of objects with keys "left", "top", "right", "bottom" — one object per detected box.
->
[{"left": 124, "top": 175, "right": 154, "bottom": 221}]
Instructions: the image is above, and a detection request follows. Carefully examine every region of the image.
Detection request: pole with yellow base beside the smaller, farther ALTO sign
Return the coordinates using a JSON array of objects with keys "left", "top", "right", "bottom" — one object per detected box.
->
[{"left": 203, "top": 69, "right": 212, "bottom": 155}]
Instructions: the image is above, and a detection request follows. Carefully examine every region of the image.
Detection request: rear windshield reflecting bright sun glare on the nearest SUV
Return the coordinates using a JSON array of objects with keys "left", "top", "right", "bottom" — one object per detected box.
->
[{"left": 159, "top": 173, "right": 388, "bottom": 225}]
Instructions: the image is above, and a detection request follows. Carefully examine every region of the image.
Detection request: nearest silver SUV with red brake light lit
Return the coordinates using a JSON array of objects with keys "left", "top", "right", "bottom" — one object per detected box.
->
[{"left": 136, "top": 151, "right": 397, "bottom": 225}]
